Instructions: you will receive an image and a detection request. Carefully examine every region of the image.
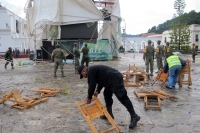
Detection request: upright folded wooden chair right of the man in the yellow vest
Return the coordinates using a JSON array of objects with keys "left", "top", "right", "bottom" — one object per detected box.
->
[{"left": 178, "top": 59, "right": 192, "bottom": 87}]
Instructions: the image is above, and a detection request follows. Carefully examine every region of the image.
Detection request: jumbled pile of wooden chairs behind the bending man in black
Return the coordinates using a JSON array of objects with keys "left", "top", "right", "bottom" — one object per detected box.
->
[{"left": 122, "top": 64, "right": 149, "bottom": 87}]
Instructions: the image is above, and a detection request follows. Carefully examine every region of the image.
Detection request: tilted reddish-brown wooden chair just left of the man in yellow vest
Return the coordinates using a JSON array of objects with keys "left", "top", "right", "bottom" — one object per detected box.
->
[{"left": 151, "top": 68, "right": 168, "bottom": 87}]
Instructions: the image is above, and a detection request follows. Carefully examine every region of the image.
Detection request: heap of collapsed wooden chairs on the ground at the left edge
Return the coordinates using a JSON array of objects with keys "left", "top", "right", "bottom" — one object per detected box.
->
[{"left": 0, "top": 89, "right": 48, "bottom": 110}]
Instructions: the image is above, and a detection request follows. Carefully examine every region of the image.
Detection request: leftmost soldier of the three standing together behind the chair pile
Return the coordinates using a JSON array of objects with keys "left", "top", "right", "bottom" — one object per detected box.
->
[{"left": 143, "top": 40, "right": 154, "bottom": 76}]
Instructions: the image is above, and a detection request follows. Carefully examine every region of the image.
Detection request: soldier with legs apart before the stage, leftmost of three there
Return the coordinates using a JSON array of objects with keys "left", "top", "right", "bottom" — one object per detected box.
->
[{"left": 51, "top": 44, "right": 66, "bottom": 77}]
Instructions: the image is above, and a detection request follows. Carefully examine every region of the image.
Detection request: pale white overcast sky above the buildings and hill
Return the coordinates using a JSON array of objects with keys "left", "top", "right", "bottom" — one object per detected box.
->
[{"left": 0, "top": 0, "right": 200, "bottom": 34}]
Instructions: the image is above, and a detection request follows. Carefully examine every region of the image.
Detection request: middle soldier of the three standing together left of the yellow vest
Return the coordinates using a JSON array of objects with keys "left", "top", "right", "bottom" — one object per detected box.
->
[{"left": 156, "top": 40, "right": 163, "bottom": 70}]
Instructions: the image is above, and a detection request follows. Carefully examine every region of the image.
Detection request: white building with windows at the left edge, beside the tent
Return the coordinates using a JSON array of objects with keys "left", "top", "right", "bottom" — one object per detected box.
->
[{"left": 0, "top": 5, "right": 29, "bottom": 53}]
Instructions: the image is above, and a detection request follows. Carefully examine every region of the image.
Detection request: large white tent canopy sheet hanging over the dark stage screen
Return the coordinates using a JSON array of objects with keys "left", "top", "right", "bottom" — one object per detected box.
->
[{"left": 26, "top": 0, "right": 103, "bottom": 39}]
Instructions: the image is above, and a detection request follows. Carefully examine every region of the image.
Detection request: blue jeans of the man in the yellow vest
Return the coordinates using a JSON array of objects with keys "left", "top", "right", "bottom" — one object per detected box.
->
[{"left": 168, "top": 66, "right": 182, "bottom": 88}]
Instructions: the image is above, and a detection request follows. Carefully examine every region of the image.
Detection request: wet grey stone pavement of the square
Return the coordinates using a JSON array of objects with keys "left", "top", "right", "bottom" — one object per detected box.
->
[{"left": 0, "top": 53, "right": 200, "bottom": 133}]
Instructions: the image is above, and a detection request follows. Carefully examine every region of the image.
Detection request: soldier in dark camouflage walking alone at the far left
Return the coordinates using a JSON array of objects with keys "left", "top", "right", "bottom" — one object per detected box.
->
[{"left": 4, "top": 47, "right": 15, "bottom": 69}]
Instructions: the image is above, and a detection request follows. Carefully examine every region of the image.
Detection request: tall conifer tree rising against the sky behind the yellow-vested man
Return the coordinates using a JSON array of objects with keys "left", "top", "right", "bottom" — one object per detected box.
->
[{"left": 170, "top": 0, "right": 190, "bottom": 50}]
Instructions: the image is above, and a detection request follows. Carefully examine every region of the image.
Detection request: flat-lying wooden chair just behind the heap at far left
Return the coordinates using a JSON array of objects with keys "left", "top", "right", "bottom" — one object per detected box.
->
[{"left": 32, "top": 88, "right": 61, "bottom": 98}]
